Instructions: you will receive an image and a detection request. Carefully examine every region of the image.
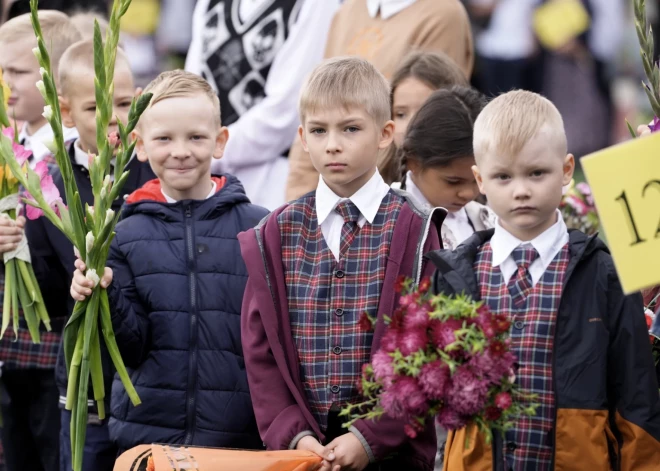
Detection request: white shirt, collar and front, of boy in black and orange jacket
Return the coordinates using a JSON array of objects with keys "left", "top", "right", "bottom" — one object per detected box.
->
[{"left": 490, "top": 210, "right": 568, "bottom": 286}]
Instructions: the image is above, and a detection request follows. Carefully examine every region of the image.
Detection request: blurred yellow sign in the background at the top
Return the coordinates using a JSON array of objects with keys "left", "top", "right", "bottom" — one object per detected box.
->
[{"left": 534, "top": 0, "right": 590, "bottom": 49}]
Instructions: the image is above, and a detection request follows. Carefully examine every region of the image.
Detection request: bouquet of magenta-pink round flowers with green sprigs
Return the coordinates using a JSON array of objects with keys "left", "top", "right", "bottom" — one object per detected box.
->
[{"left": 340, "top": 279, "right": 535, "bottom": 442}]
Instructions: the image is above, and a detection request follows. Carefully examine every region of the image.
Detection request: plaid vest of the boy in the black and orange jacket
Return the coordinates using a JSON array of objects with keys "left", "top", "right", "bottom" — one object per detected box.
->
[{"left": 474, "top": 242, "right": 569, "bottom": 471}]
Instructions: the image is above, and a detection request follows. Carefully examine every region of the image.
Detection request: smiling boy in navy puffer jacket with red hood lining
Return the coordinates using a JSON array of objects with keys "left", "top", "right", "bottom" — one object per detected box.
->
[{"left": 71, "top": 71, "right": 267, "bottom": 450}]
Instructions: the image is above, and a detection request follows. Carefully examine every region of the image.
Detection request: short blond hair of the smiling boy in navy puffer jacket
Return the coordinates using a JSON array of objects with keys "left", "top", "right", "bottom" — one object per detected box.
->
[{"left": 144, "top": 69, "right": 220, "bottom": 124}]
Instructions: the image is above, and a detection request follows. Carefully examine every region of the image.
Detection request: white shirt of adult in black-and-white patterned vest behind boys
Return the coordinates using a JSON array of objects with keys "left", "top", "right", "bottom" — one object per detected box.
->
[{"left": 186, "top": 0, "right": 341, "bottom": 210}]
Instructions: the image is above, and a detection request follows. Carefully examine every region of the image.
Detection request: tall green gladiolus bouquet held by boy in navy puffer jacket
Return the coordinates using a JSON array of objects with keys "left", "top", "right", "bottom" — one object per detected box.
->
[{"left": 0, "top": 0, "right": 151, "bottom": 471}]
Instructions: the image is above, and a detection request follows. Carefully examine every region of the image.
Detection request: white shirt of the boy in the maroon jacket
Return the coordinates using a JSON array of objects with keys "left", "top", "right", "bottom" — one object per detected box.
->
[{"left": 316, "top": 172, "right": 390, "bottom": 261}]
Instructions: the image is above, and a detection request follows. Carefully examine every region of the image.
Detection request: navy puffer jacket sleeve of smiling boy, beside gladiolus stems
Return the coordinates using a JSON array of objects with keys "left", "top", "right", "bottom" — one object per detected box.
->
[{"left": 108, "top": 238, "right": 149, "bottom": 368}]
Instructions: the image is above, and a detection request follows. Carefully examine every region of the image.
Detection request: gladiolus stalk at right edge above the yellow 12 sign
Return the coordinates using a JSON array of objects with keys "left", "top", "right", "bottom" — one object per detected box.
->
[{"left": 626, "top": 0, "right": 660, "bottom": 139}]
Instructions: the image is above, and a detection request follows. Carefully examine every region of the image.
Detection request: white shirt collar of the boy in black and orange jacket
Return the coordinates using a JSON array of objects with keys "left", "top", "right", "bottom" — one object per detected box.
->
[{"left": 490, "top": 210, "right": 568, "bottom": 267}]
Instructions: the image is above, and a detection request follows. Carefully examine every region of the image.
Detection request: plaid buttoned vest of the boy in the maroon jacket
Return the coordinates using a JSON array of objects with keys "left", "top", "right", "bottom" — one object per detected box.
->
[{"left": 278, "top": 191, "right": 404, "bottom": 430}]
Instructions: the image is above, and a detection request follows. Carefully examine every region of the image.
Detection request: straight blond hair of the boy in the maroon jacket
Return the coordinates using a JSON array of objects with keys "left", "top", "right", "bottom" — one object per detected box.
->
[{"left": 299, "top": 57, "right": 391, "bottom": 125}]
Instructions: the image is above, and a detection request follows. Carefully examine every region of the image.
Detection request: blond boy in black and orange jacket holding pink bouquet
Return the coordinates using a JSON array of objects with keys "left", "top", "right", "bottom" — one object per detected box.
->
[{"left": 429, "top": 91, "right": 660, "bottom": 471}]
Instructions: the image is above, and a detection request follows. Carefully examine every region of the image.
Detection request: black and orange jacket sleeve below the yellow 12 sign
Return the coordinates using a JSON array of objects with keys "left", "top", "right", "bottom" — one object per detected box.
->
[{"left": 607, "top": 256, "right": 660, "bottom": 471}]
